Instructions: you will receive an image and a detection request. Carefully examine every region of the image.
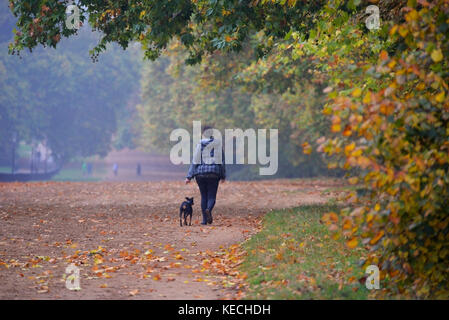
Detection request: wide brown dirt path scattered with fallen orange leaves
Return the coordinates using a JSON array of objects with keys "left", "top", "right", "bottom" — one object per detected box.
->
[{"left": 0, "top": 180, "right": 339, "bottom": 299}]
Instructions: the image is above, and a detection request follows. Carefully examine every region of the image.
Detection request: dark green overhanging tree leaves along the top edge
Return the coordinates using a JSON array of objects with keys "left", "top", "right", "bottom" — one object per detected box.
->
[{"left": 10, "top": 0, "right": 325, "bottom": 63}]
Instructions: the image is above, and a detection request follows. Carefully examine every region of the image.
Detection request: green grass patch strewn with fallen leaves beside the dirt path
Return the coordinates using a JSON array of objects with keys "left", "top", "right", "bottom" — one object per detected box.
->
[{"left": 240, "top": 204, "right": 369, "bottom": 299}]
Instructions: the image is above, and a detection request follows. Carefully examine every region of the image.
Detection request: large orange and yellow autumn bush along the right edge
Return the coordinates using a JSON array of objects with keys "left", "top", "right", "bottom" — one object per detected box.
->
[{"left": 319, "top": 0, "right": 449, "bottom": 298}]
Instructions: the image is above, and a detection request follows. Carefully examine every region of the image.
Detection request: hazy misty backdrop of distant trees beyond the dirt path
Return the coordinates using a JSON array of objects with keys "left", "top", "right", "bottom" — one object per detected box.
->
[{"left": 0, "top": 0, "right": 338, "bottom": 181}]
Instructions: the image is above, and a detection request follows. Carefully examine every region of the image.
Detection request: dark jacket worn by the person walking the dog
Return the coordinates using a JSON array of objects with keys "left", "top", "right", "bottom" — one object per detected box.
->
[{"left": 187, "top": 137, "right": 226, "bottom": 180}]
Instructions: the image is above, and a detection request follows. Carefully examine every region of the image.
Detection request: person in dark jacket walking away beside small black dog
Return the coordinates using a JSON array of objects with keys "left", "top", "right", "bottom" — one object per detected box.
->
[{"left": 185, "top": 126, "right": 226, "bottom": 225}]
